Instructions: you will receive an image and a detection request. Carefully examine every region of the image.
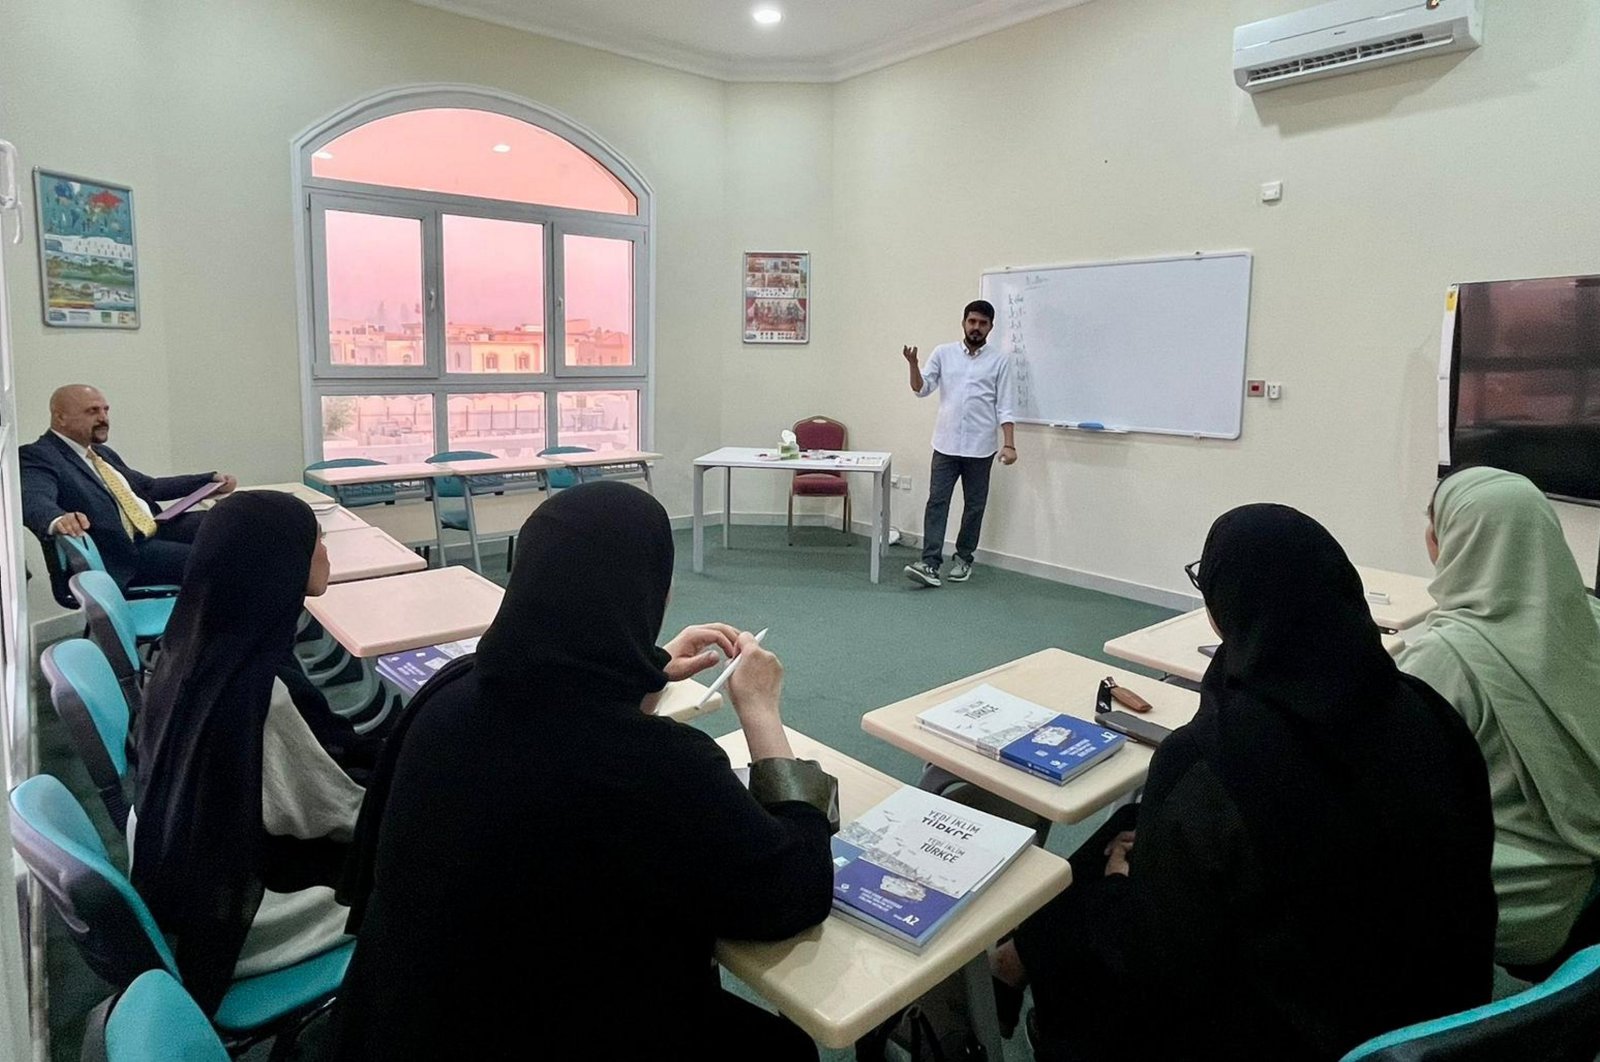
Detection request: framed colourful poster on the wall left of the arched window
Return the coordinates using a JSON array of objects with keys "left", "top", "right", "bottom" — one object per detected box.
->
[{"left": 34, "top": 170, "right": 139, "bottom": 328}]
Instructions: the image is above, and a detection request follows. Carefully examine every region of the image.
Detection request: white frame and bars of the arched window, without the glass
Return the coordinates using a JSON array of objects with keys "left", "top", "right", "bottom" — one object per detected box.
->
[{"left": 293, "top": 86, "right": 654, "bottom": 464}]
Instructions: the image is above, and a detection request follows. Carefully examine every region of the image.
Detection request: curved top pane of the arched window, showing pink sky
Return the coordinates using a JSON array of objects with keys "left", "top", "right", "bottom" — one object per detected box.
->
[{"left": 310, "top": 107, "right": 638, "bottom": 214}]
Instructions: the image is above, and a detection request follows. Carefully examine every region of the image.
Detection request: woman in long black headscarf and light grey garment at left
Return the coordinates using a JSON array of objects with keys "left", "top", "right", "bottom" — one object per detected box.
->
[{"left": 128, "top": 491, "right": 366, "bottom": 1012}]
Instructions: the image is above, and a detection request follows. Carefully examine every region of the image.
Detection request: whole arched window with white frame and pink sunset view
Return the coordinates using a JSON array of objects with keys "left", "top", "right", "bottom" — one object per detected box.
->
[{"left": 296, "top": 90, "right": 651, "bottom": 461}]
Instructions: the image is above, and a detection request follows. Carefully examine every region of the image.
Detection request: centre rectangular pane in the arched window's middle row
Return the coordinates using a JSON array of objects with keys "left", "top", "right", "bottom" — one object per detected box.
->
[{"left": 445, "top": 214, "right": 546, "bottom": 373}]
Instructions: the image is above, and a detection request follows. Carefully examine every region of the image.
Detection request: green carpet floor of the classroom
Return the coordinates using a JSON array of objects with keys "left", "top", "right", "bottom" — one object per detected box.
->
[{"left": 38, "top": 526, "right": 1171, "bottom": 1062}]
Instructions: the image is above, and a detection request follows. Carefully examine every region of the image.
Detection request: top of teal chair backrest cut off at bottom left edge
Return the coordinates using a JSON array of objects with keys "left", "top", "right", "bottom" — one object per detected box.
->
[{"left": 83, "top": 969, "right": 229, "bottom": 1062}]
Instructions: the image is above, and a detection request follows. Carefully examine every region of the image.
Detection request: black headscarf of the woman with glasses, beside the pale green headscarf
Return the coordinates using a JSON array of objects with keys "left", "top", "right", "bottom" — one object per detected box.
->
[{"left": 1195, "top": 505, "right": 1482, "bottom": 878}]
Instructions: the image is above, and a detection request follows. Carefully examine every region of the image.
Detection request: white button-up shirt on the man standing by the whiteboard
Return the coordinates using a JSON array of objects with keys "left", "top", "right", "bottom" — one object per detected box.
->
[{"left": 917, "top": 342, "right": 1016, "bottom": 457}]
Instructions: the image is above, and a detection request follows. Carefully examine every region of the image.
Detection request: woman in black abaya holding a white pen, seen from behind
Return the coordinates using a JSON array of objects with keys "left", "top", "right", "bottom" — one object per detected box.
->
[{"left": 333, "top": 483, "right": 837, "bottom": 1062}]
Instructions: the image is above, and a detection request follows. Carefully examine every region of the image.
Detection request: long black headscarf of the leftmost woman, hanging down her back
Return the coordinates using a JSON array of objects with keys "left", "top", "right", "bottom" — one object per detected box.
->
[{"left": 133, "top": 491, "right": 328, "bottom": 1012}]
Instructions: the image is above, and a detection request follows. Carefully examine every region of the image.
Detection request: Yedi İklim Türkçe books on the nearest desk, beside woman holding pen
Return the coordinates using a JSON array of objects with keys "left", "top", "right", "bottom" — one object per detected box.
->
[{"left": 834, "top": 785, "right": 1035, "bottom": 952}]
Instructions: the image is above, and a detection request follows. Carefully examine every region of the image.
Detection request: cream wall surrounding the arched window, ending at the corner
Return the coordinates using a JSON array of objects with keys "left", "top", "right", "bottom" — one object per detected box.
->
[{"left": 0, "top": 0, "right": 732, "bottom": 617}]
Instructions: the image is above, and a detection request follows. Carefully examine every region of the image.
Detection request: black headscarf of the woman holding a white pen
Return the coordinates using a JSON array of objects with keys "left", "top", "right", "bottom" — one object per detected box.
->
[{"left": 339, "top": 483, "right": 674, "bottom": 932}]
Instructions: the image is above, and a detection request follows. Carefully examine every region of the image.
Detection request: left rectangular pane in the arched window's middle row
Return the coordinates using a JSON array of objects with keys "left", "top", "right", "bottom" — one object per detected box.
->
[{"left": 323, "top": 210, "right": 426, "bottom": 365}]
